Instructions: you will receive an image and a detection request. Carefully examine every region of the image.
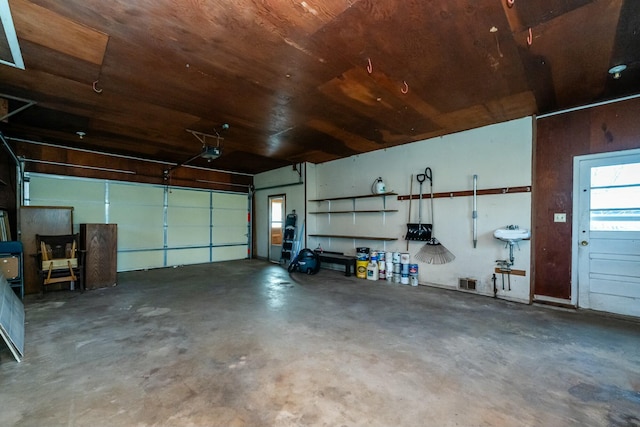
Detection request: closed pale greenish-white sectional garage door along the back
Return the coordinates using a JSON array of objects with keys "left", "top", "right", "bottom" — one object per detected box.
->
[{"left": 25, "top": 174, "right": 250, "bottom": 271}]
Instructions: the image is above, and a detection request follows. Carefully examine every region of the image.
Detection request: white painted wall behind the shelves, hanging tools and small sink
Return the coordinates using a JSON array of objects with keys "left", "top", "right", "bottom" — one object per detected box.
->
[{"left": 255, "top": 117, "right": 533, "bottom": 302}]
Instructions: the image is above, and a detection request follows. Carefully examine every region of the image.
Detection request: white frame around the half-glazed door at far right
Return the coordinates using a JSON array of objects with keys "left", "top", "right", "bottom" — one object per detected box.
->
[{"left": 571, "top": 148, "right": 640, "bottom": 307}]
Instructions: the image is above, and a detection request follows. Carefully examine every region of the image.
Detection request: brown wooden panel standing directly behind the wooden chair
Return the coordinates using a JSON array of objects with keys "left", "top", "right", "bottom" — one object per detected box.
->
[{"left": 20, "top": 206, "right": 73, "bottom": 294}]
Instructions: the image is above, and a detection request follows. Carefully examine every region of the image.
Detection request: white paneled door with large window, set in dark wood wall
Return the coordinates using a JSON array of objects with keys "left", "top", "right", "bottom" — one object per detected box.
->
[{"left": 573, "top": 150, "right": 640, "bottom": 317}]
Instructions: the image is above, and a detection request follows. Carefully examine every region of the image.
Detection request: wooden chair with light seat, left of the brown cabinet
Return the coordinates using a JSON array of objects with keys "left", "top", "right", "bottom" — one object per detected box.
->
[{"left": 36, "top": 234, "right": 84, "bottom": 292}]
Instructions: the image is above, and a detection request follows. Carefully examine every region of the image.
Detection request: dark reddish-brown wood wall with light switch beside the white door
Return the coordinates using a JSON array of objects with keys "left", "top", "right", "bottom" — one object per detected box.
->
[{"left": 532, "top": 99, "right": 640, "bottom": 299}]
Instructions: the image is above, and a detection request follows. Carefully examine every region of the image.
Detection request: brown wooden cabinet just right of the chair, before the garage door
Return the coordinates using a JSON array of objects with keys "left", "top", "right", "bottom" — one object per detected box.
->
[{"left": 80, "top": 224, "right": 118, "bottom": 289}]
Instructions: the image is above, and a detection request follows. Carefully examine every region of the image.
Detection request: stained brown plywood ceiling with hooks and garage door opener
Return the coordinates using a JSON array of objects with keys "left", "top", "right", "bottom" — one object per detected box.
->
[{"left": 0, "top": 0, "right": 640, "bottom": 174}]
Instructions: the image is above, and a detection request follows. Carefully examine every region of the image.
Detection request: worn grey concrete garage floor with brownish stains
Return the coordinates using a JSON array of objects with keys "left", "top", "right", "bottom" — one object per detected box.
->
[{"left": 0, "top": 260, "right": 640, "bottom": 427}]
